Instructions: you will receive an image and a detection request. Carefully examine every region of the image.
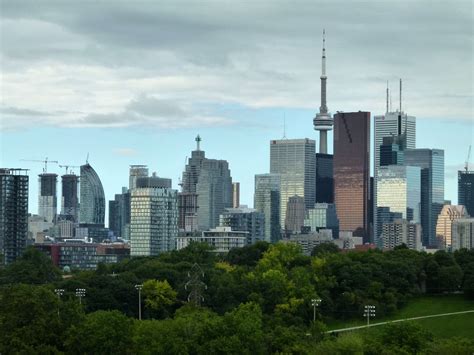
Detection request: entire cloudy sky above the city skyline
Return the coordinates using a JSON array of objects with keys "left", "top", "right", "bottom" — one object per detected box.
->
[{"left": 0, "top": 0, "right": 474, "bottom": 222}]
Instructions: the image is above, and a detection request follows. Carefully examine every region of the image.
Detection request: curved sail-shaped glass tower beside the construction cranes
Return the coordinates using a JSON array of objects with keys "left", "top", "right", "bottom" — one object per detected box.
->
[{"left": 79, "top": 163, "right": 105, "bottom": 227}]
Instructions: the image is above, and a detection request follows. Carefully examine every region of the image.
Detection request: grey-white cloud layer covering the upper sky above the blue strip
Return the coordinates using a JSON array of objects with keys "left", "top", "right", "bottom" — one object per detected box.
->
[{"left": 0, "top": 0, "right": 474, "bottom": 129}]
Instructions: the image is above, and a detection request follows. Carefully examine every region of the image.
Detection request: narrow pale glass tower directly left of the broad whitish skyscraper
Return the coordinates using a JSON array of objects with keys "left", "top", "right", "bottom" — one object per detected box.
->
[{"left": 253, "top": 174, "right": 281, "bottom": 243}]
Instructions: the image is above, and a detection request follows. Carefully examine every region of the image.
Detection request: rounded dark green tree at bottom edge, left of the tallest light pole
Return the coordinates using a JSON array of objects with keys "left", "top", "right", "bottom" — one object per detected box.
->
[{"left": 65, "top": 311, "right": 133, "bottom": 354}]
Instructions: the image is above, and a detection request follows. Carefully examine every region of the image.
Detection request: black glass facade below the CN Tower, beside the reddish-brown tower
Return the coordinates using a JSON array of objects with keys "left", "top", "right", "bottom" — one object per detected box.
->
[{"left": 316, "top": 153, "right": 334, "bottom": 203}]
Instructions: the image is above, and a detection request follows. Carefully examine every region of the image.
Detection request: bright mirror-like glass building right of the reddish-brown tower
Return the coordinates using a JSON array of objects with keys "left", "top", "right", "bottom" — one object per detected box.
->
[{"left": 375, "top": 165, "right": 421, "bottom": 242}]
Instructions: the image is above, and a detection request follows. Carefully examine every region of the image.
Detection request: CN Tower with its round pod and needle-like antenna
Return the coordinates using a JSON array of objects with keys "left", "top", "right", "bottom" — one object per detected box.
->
[{"left": 313, "top": 30, "right": 333, "bottom": 154}]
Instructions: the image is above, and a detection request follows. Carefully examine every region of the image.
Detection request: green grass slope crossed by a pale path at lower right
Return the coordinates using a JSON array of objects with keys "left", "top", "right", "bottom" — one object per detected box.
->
[{"left": 328, "top": 295, "right": 474, "bottom": 339}]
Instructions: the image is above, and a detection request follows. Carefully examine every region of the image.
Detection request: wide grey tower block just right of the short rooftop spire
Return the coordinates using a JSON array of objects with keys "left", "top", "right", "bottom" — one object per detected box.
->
[{"left": 196, "top": 159, "right": 232, "bottom": 230}]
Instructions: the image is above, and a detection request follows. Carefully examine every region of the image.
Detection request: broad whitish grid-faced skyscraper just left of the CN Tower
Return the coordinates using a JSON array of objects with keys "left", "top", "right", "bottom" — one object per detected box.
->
[{"left": 270, "top": 138, "right": 316, "bottom": 226}]
